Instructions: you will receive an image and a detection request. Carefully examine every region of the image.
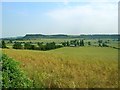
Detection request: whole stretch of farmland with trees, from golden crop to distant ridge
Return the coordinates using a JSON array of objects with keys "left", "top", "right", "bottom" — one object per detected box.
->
[{"left": 1, "top": 35, "right": 120, "bottom": 88}]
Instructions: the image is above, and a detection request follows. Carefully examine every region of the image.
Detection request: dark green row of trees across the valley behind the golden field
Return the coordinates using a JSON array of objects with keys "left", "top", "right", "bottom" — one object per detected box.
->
[{"left": 0, "top": 39, "right": 109, "bottom": 51}]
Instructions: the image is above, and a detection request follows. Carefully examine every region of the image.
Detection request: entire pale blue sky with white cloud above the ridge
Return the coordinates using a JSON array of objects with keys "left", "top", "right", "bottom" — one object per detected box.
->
[{"left": 0, "top": 0, "right": 119, "bottom": 37}]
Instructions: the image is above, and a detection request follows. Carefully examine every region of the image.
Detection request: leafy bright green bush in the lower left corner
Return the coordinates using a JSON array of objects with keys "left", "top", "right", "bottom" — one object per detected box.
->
[{"left": 0, "top": 54, "right": 32, "bottom": 88}]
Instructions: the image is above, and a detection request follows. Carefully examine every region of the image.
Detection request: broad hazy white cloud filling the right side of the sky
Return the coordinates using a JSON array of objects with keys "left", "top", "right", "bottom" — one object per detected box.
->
[{"left": 47, "top": 3, "right": 118, "bottom": 34}]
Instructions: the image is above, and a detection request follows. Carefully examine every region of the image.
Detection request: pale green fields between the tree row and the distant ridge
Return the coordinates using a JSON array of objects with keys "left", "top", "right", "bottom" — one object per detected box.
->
[{"left": 5, "top": 38, "right": 120, "bottom": 48}]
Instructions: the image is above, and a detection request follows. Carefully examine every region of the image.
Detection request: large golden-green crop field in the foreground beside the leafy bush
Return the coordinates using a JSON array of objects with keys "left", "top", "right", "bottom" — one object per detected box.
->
[{"left": 3, "top": 47, "right": 118, "bottom": 88}]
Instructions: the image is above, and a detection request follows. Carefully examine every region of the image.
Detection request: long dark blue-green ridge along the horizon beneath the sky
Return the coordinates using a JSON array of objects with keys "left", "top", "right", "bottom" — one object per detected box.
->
[{"left": 2, "top": 34, "right": 120, "bottom": 40}]
